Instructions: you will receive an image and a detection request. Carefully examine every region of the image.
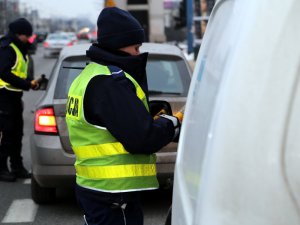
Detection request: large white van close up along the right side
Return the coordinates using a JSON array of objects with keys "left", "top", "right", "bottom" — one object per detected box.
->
[{"left": 172, "top": 0, "right": 300, "bottom": 225}]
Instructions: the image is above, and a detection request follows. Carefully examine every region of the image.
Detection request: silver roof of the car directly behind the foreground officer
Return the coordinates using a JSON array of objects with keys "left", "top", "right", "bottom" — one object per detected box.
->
[{"left": 60, "top": 43, "right": 184, "bottom": 58}]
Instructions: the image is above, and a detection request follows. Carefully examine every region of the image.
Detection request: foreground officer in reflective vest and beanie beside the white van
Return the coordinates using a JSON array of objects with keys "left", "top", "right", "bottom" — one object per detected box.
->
[{"left": 66, "top": 7, "right": 180, "bottom": 225}]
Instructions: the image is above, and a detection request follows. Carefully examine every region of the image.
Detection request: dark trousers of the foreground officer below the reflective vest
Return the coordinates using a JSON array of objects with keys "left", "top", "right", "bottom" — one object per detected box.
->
[{"left": 76, "top": 185, "right": 144, "bottom": 225}]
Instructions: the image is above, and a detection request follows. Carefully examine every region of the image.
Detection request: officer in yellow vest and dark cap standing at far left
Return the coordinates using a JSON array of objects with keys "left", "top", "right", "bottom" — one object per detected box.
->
[{"left": 0, "top": 18, "right": 38, "bottom": 181}]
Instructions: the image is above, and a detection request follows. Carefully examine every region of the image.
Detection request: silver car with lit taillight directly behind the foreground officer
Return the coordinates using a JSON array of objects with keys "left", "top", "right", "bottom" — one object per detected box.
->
[{"left": 30, "top": 43, "right": 191, "bottom": 203}]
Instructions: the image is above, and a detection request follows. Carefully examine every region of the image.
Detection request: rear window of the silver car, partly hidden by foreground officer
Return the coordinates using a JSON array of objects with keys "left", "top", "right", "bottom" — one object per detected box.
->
[{"left": 54, "top": 55, "right": 190, "bottom": 99}]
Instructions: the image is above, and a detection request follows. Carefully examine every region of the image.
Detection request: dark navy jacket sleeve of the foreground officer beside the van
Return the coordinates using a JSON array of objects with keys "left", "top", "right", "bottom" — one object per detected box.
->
[{"left": 84, "top": 76, "right": 174, "bottom": 154}]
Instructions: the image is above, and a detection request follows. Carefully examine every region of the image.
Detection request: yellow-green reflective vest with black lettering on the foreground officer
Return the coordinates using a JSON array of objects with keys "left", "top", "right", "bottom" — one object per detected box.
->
[{"left": 66, "top": 63, "right": 158, "bottom": 192}]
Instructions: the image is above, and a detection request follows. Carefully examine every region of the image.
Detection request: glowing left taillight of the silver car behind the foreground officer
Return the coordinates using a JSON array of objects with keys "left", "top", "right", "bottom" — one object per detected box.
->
[{"left": 34, "top": 108, "right": 58, "bottom": 134}]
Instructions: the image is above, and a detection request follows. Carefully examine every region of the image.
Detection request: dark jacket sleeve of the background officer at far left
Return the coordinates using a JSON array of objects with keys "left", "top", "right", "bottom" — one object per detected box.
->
[{"left": 0, "top": 47, "right": 31, "bottom": 90}]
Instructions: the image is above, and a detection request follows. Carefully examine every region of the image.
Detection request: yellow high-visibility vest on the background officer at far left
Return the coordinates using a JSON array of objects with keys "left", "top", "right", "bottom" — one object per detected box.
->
[{"left": 0, "top": 43, "right": 29, "bottom": 91}]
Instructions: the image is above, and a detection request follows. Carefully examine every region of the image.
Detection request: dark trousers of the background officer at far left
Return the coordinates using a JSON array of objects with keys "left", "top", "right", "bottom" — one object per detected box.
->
[{"left": 0, "top": 95, "right": 24, "bottom": 169}]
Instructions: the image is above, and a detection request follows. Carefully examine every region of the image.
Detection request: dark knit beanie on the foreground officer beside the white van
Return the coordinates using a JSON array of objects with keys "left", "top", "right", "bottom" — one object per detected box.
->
[{"left": 97, "top": 7, "right": 145, "bottom": 50}]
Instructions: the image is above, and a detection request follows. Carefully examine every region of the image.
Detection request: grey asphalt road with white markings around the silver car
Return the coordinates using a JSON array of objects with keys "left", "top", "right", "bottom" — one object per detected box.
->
[{"left": 0, "top": 46, "right": 172, "bottom": 225}]
